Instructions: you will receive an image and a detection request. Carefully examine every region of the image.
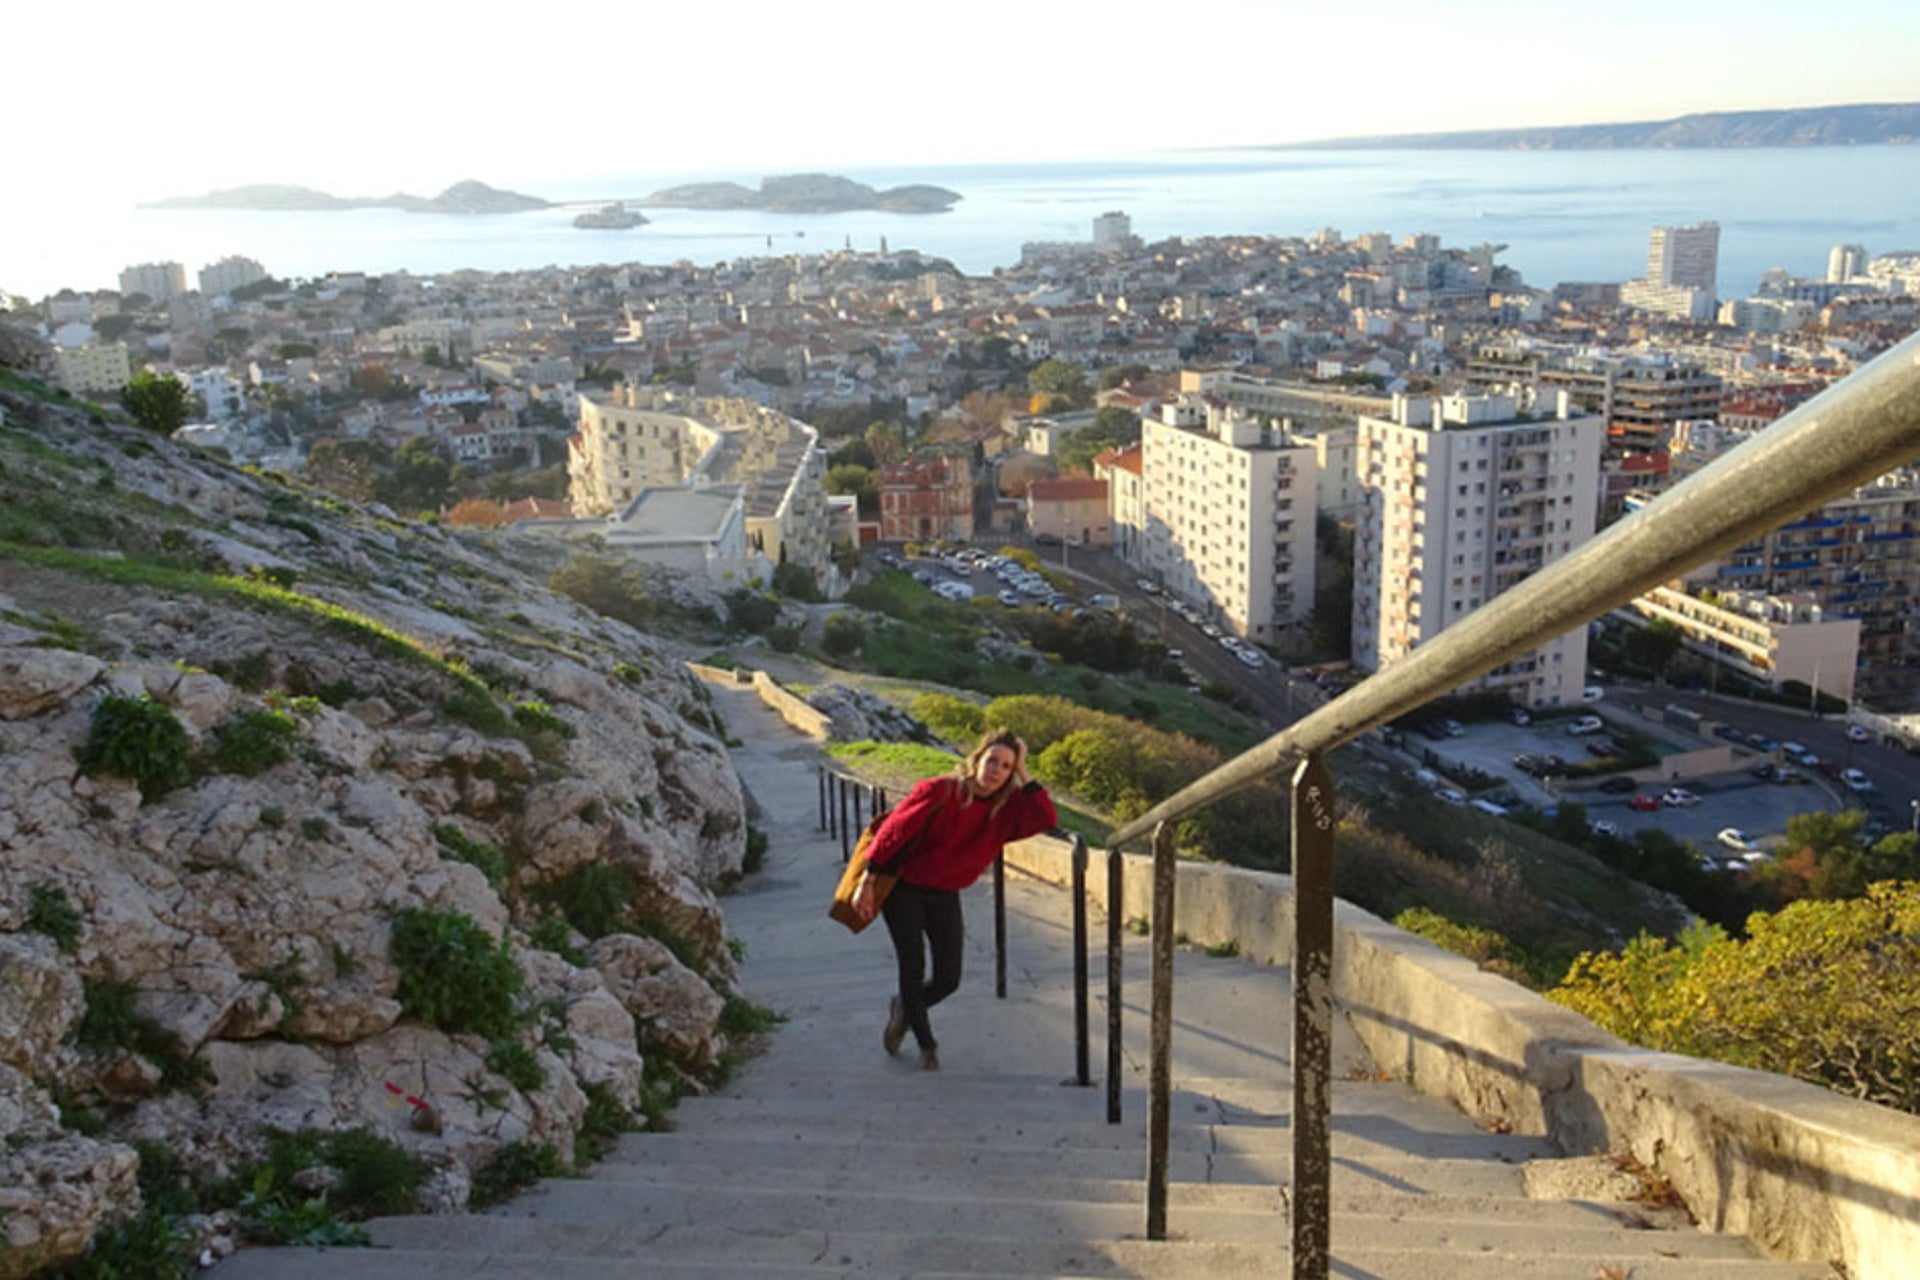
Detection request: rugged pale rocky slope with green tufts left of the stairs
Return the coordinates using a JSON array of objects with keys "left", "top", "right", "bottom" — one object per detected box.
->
[{"left": 0, "top": 395, "right": 764, "bottom": 1280}]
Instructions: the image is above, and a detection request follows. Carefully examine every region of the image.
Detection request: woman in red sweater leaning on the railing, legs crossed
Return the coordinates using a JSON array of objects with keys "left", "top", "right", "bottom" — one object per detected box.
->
[{"left": 852, "top": 729, "right": 1060, "bottom": 1071}]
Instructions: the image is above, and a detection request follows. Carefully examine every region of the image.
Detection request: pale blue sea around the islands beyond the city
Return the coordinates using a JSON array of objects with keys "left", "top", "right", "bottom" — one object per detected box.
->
[{"left": 0, "top": 146, "right": 1920, "bottom": 299}]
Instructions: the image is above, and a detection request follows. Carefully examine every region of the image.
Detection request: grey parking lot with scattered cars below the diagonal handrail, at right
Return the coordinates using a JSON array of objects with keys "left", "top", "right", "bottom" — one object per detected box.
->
[{"left": 1405, "top": 702, "right": 1851, "bottom": 852}]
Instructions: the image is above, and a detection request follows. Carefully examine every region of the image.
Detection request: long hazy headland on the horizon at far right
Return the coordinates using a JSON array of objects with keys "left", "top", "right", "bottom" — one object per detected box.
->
[{"left": 1269, "top": 102, "right": 1920, "bottom": 152}]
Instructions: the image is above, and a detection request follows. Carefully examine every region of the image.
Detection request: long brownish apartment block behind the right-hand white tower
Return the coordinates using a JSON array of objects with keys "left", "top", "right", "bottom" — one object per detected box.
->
[{"left": 1467, "top": 340, "right": 1726, "bottom": 453}]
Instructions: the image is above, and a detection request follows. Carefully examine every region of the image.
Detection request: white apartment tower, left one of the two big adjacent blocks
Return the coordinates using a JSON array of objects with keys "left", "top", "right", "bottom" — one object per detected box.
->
[{"left": 1123, "top": 395, "right": 1315, "bottom": 641}]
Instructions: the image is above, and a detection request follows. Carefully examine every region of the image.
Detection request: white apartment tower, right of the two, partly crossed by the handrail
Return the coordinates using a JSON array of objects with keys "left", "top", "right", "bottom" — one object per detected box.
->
[{"left": 1354, "top": 393, "right": 1605, "bottom": 706}]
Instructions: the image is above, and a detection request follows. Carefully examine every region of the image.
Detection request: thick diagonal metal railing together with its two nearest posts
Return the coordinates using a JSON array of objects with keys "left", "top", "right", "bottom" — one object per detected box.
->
[{"left": 1108, "top": 322, "right": 1920, "bottom": 1280}]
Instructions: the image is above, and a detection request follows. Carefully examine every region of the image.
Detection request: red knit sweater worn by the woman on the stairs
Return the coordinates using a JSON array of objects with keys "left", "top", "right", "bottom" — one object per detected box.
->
[{"left": 866, "top": 777, "right": 1060, "bottom": 889}]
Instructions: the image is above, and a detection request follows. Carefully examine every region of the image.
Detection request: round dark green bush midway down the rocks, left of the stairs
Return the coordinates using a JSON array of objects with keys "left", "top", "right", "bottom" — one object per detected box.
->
[{"left": 392, "top": 908, "right": 522, "bottom": 1038}]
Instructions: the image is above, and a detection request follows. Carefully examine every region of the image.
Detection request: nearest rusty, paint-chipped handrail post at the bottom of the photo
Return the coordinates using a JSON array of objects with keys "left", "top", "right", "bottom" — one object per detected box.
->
[{"left": 1292, "top": 754, "right": 1334, "bottom": 1280}]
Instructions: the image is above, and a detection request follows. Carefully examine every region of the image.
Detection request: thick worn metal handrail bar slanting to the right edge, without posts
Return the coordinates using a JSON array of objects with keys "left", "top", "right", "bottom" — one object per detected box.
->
[{"left": 1108, "top": 334, "right": 1920, "bottom": 848}]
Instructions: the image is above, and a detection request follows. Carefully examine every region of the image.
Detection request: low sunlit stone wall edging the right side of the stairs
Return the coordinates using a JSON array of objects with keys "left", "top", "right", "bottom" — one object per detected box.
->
[{"left": 1006, "top": 837, "right": 1920, "bottom": 1280}]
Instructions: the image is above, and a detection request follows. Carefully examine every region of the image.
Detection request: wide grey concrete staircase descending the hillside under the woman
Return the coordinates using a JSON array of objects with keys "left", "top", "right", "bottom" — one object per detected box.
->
[{"left": 215, "top": 687, "right": 1830, "bottom": 1280}]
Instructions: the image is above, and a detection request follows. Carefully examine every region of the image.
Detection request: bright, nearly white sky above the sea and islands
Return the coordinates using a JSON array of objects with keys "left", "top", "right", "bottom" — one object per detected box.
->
[{"left": 11, "top": 0, "right": 1920, "bottom": 202}]
